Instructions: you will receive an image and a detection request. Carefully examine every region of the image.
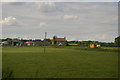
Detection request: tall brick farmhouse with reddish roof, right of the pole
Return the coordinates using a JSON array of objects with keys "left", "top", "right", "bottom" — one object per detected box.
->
[{"left": 52, "top": 36, "right": 67, "bottom": 46}]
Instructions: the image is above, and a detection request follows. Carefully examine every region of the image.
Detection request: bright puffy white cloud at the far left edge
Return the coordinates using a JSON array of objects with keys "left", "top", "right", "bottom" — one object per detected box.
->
[{"left": 0, "top": 16, "right": 16, "bottom": 25}]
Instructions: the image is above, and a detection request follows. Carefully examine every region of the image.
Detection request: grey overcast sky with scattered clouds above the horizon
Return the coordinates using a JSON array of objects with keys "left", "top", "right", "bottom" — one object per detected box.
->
[{"left": 0, "top": 2, "right": 118, "bottom": 42}]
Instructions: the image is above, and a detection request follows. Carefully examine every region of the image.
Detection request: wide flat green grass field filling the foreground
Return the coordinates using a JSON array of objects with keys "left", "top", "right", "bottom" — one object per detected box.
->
[{"left": 2, "top": 47, "right": 118, "bottom": 78}]
